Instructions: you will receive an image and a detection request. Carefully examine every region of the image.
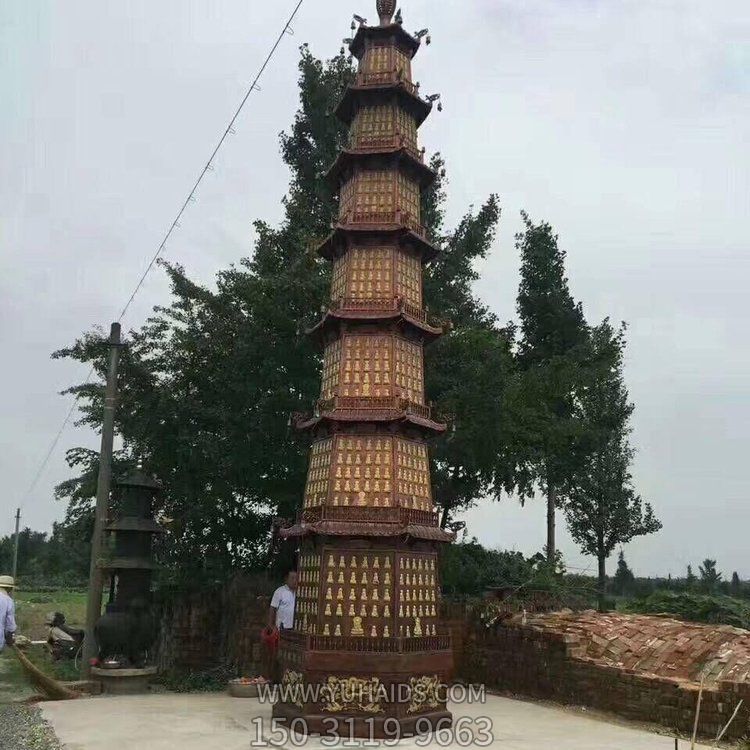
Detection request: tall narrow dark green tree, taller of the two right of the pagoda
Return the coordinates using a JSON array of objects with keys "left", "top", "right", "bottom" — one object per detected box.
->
[{"left": 516, "top": 213, "right": 586, "bottom": 561}]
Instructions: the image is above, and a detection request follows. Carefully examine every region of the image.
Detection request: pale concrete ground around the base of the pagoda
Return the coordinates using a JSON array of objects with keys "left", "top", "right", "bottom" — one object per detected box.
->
[{"left": 40, "top": 693, "right": 707, "bottom": 750}]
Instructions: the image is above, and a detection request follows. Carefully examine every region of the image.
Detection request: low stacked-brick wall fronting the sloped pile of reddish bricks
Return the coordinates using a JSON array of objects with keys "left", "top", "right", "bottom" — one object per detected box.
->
[{"left": 459, "top": 622, "right": 750, "bottom": 739}]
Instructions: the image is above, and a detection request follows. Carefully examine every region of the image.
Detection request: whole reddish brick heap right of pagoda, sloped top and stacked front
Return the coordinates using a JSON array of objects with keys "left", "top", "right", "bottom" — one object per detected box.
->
[{"left": 460, "top": 611, "right": 750, "bottom": 738}]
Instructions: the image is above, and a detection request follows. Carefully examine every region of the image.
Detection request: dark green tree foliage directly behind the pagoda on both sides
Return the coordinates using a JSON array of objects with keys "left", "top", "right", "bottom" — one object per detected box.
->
[{"left": 55, "top": 47, "right": 515, "bottom": 576}]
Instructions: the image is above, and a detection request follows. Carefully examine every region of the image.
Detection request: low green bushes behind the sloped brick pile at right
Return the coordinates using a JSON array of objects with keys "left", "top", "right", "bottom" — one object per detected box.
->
[{"left": 624, "top": 591, "right": 750, "bottom": 630}]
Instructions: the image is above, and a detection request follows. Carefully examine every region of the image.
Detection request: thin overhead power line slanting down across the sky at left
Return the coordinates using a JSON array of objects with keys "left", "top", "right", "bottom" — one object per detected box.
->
[{"left": 20, "top": 0, "right": 304, "bottom": 508}]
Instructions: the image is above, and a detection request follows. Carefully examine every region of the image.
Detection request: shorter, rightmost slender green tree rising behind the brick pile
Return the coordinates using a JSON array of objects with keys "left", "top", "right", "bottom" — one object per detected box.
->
[{"left": 565, "top": 320, "right": 661, "bottom": 609}]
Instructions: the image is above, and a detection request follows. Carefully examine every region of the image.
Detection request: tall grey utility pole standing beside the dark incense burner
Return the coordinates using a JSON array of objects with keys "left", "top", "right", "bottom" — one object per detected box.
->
[{"left": 82, "top": 323, "right": 121, "bottom": 677}]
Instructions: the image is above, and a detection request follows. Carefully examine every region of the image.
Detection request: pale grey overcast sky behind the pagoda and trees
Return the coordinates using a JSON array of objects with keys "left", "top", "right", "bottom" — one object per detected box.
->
[{"left": 0, "top": 0, "right": 750, "bottom": 578}]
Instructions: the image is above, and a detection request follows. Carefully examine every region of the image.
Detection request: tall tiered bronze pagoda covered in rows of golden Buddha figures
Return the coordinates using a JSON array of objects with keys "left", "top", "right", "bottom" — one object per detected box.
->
[{"left": 274, "top": 0, "right": 453, "bottom": 737}]
